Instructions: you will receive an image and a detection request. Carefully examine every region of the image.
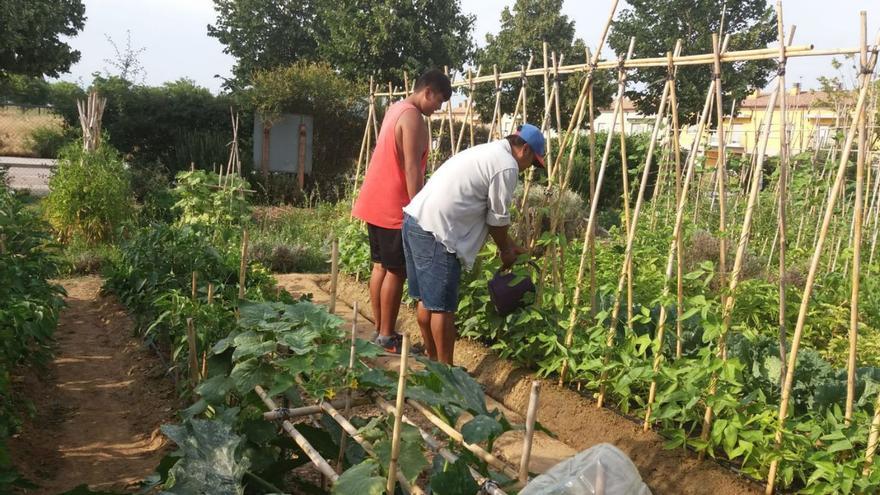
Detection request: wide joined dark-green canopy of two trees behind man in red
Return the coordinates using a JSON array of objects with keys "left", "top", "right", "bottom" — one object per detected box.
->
[{"left": 208, "top": 0, "right": 474, "bottom": 84}]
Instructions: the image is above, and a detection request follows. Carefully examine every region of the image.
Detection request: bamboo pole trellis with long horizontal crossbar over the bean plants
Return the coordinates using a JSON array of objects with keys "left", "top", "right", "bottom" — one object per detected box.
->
[{"left": 346, "top": 1, "right": 880, "bottom": 492}]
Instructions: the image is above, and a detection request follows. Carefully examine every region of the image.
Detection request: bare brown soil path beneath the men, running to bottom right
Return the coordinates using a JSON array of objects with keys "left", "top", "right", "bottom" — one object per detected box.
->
[{"left": 277, "top": 274, "right": 763, "bottom": 495}]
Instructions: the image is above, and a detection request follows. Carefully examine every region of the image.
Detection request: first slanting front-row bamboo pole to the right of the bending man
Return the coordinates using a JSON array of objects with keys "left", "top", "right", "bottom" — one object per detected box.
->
[{"left": 557, "top": 40, "right": 634, "bottom": 388}]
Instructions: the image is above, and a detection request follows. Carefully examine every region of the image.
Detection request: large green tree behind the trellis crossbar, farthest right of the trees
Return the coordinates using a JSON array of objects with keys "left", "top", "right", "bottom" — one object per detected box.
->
[{"left": 608, "top": 0, "right": 777, "bottom": 122}]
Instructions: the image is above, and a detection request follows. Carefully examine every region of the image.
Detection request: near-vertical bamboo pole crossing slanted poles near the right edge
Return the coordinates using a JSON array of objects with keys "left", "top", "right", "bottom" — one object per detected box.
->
[{"left": 844, "top": 10, "right": 868, "bottom": 424}]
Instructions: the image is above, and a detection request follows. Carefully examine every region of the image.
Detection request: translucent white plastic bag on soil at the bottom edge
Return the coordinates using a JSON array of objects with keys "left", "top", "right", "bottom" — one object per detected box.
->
[{"left": 519, "top": 443, "right": 651, "bottom": 495}]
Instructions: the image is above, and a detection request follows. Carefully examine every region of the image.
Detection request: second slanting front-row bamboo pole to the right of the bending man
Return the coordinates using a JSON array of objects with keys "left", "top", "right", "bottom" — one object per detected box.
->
[{"left": 591, "top": 40, "right": 674, "bottom": 407}]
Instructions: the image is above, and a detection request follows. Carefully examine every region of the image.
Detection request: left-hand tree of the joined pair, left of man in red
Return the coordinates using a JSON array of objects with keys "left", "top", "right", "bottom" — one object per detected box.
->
[{"left": 208, "top": 0, "right": 318, "bottom": 83}]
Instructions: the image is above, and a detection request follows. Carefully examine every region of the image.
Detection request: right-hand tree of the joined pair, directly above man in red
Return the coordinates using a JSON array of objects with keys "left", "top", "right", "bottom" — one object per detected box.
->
[{"left": 318, "top": 0, "right": 474, "bottom": 85}]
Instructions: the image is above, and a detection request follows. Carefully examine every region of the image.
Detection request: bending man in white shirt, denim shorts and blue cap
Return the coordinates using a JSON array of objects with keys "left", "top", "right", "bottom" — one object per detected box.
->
[{"left": 403, "top": 124, "right": 544, "bottom": 365}]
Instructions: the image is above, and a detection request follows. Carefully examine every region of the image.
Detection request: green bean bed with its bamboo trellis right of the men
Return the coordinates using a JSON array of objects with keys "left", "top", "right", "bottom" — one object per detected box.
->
[{"left": 342, "top": 2, "right": 880, "bottom": 493}]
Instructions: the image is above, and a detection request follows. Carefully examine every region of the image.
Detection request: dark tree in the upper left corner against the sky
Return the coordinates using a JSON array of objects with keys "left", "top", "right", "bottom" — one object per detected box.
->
[{"left": 0, "top": 0, "right": 86, "bottom": 80}]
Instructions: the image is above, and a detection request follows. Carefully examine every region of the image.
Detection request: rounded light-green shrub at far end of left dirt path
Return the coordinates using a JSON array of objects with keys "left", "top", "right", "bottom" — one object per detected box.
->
[{"left": 45, "top": 142, "right": 133, "bottom": 242}]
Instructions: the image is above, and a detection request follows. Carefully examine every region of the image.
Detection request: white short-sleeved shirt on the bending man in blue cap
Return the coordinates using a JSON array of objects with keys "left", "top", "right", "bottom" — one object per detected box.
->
[{"left": 403, "top": 139, "right": 519, "bottom": 269}]
